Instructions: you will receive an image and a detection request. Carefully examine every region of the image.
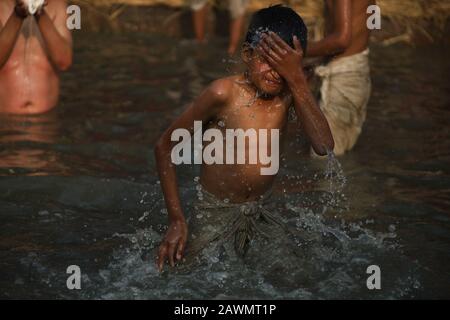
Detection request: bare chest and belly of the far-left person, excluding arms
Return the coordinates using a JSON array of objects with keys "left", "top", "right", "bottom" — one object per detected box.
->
[{"left": 0, "top": 1, "right": 59, "bottom": 114}]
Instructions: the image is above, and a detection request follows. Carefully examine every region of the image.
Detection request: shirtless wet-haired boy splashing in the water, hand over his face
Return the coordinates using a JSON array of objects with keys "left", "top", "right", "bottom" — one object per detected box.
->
[{"left": 155, "top": 5, "right": 334, "bottom": 270}]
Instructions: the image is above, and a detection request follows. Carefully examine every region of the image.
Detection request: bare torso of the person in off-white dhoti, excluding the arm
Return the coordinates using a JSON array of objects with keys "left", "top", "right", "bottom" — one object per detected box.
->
[{"left": 325, "top": 0, "right": 375, "bottom": 59}]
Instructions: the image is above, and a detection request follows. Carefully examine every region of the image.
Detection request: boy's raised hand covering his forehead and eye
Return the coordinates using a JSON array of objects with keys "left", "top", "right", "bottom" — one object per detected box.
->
[{"left": 258, "top": 32, "right": 303, "bottom": 81}]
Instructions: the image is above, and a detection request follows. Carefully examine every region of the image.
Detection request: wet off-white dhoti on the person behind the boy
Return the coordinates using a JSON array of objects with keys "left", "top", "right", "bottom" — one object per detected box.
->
[{"left": 315, "top": 49, "right": 371, "bottom": 155}]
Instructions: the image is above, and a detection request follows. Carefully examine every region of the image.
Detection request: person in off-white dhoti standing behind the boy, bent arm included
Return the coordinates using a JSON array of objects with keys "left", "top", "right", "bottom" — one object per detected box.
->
[{"left": 307, "top": 0, "right": 375, "bottom": 155}]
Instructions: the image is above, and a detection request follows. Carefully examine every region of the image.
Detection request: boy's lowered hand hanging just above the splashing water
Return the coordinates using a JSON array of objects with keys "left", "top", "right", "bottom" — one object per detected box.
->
[{"left": 157, "top": 221, "right": 187, "bottom": 272}]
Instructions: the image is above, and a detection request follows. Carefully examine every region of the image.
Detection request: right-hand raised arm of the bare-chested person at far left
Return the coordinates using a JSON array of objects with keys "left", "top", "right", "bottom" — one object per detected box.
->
[{"left": 36, "top": 1, "right": 72, "bottom": 71}]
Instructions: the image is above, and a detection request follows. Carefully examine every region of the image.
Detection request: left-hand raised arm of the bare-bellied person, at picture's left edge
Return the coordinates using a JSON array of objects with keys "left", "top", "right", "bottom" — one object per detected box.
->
[{"left": 0, "top": 1, "right": 28, "bottom": 69}]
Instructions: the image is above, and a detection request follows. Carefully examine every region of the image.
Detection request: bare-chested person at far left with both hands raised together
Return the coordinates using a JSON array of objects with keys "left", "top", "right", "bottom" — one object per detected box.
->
[{"left": 0, "top": 0, "right": 72, "bottom": 114}]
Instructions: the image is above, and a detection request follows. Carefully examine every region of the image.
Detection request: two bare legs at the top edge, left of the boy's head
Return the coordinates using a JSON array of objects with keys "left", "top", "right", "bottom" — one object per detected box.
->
[{"left": 188, "top": 0, "right": 249, "bottom": 55}]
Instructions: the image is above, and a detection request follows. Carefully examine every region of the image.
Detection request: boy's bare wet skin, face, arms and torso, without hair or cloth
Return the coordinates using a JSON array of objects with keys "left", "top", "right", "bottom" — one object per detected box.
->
[{"left": 155, "top": 33, "right": 334, "bottom": 270}]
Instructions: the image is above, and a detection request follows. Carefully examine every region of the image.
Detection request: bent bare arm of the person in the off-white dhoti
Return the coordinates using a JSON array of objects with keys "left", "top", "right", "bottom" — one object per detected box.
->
[{"left": 306, "top": 0, "right": 352, "bottom": 57}]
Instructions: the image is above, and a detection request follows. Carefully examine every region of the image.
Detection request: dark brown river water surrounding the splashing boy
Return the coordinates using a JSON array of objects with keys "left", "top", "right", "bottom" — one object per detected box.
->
[{"left": 0, "top": 34, "right": 450, "bottom": 299}]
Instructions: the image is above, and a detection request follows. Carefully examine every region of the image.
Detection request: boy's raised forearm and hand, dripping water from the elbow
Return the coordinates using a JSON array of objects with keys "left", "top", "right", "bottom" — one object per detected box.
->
[{"left": 258, "top": 32, "right": 334, "bottom": 155}]
